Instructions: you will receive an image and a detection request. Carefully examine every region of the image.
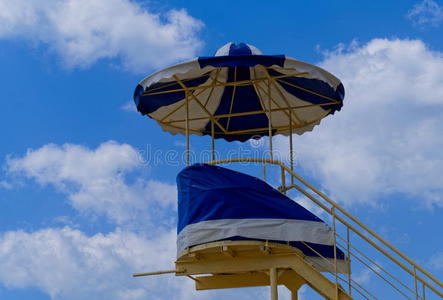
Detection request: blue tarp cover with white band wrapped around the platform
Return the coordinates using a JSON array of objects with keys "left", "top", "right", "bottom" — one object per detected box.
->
[{"left": 177, "top": 164, "right": 347, "bottom": 273}]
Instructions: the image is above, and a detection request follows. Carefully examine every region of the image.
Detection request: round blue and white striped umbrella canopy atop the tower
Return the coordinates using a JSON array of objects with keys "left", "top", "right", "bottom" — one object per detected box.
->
[{"left": 134, "top": 43, "right": 344, "bottom": 141}]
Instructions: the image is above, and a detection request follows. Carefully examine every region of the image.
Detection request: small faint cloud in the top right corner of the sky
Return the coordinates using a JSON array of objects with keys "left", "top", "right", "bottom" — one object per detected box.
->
[{"left": 406, "top": 0, "right": 443, "bottom": 27}]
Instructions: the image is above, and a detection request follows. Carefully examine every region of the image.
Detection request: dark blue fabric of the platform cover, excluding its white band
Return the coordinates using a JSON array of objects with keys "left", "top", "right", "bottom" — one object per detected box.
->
[{"left": 177, "top": 164, "right": 344, "bottom": 259}]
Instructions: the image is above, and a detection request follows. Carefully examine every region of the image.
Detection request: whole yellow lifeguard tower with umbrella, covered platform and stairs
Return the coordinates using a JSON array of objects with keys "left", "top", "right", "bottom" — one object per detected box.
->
[{"left": 134, "top": 43, "right": 443, "bottom": 300}]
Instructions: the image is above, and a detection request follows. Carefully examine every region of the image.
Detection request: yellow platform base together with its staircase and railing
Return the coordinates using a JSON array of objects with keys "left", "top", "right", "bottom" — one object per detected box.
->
[{"left": 134, "top": 158, "right": 443, "bottom": 300}]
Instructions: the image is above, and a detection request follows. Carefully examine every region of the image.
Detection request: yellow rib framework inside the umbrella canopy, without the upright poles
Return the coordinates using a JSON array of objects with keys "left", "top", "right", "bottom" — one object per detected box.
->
[{"left": 143, "top": 66, "right": 340, "bottom": 152}]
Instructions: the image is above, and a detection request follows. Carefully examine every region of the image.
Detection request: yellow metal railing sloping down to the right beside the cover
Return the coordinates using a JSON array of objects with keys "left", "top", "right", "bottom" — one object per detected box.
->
[{"left": 208, "top": 158, "right": 443, "bottom": 300}]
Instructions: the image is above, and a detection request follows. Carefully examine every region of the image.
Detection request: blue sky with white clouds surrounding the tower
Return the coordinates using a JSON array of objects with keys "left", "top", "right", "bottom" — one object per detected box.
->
[{"left": 0, "top": 0, "right": 443, "bottom": 299}]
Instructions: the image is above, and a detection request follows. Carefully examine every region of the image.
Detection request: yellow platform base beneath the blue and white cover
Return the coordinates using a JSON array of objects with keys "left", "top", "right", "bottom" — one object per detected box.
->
[{"left": 134, "top": 241, "right": 352, "bottom": 300}]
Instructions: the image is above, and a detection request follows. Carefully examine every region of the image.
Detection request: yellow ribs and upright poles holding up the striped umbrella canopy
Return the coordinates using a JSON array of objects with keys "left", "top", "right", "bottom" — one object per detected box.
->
[{"left": 149, "top": 66, "right": 340, "bottom": 170}]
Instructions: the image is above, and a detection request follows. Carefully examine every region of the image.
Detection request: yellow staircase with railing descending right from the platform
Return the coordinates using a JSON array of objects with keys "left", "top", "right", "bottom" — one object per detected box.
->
[{"left": 206, "top": 158, "right": 443, "bottom": 300}]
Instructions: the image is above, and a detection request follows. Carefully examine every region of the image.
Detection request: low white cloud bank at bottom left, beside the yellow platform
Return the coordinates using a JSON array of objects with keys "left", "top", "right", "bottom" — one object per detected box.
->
[{"left": 0, "top": 227, "right": 205, "bottom": 299}]
